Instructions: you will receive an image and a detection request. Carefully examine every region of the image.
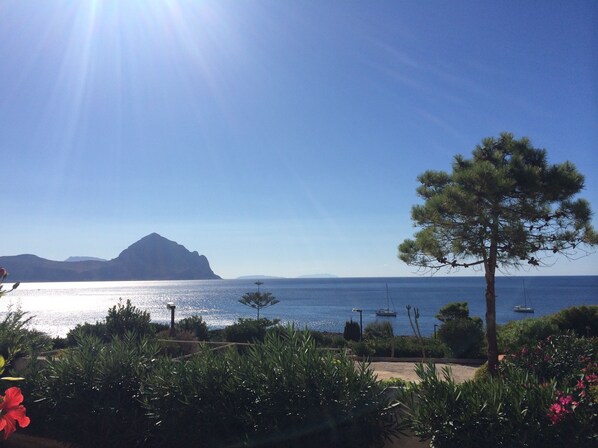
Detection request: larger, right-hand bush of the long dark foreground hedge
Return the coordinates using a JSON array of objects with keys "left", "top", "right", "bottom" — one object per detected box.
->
[{"left": 144, "top": 328, "right": 393, "bottom": 448}]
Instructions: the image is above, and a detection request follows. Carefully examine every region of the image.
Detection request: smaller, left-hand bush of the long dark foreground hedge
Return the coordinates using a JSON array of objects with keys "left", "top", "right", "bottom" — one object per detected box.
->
[{"left": 24, "top": 334, "right": 157, "bottom": 447}]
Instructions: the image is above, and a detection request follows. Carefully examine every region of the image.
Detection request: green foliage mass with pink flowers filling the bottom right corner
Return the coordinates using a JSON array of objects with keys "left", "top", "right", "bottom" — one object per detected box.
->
[{"left": 399, "top": 335, "right": 598, "bottom": 448}]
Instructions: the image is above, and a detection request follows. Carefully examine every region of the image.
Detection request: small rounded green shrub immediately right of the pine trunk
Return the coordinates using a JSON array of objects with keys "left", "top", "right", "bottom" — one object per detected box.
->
[{"left": 497, "top": 316, "right": 560, "bottom": 353}]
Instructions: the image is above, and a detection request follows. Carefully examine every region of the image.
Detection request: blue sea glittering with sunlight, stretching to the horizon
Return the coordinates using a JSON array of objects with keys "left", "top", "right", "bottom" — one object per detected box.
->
[{"left": 0, "top": 276, "right": 598, "bottom": 337}]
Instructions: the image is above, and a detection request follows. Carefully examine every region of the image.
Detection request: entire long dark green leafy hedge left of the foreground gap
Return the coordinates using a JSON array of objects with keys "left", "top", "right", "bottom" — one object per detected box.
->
[{"left": 25, "top": 328, "right": 394, "bottom": 447}]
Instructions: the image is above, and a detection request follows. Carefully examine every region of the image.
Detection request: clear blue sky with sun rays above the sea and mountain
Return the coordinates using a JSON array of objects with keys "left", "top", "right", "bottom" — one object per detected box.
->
[{"left": 0, "top": 0, "right": 598, "bottom": 278}]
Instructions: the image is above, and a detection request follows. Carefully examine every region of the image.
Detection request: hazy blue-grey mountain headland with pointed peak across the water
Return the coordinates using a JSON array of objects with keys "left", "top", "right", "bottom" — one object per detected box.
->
[{"left": 0, "top": 233, "right": 220, "bottom": 282}]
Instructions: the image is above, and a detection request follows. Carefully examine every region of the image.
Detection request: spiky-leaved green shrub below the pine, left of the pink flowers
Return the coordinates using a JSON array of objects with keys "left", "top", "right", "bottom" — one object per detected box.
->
[{"left": 399, "top": 365, "right": 571, "bottom": 448}]
